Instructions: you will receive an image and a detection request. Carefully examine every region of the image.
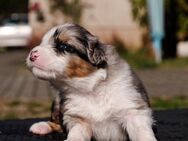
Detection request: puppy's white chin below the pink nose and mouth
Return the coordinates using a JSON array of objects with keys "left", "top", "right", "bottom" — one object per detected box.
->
[{"left": 31, "top": 67, "right": 56, "bottom": 80}]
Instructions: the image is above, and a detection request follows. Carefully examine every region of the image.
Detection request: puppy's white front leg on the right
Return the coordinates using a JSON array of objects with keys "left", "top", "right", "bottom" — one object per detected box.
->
[{"left": 123, "top": 109, "right": 157, "bottom": 141}]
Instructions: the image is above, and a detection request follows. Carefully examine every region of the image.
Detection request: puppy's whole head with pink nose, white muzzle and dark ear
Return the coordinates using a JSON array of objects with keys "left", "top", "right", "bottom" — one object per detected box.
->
[{"left": 26, "top": 24, "right": 107, "bottom": 80}]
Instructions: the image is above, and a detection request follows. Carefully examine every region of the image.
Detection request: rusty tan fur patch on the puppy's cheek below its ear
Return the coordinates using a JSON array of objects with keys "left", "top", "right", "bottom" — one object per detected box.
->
[{"left": 66, "top": 57, "right": 96, "bottom": 78}]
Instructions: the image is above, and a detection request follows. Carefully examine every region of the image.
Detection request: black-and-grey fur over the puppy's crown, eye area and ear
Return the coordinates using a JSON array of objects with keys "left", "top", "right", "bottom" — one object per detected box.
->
[{"left": 53, "top": 24, "right": 107, "bottom": 68}]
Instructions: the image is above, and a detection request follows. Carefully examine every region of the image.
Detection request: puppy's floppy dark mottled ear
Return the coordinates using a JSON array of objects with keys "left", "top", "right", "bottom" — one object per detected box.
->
[{"left": 87, "top": 36, "right": 107, "bottom": 68}]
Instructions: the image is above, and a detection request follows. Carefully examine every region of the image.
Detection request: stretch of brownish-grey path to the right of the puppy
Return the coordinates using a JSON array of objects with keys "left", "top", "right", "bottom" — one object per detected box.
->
[{"left": 137, "top": 70, "right": 188, "bottom": 97}]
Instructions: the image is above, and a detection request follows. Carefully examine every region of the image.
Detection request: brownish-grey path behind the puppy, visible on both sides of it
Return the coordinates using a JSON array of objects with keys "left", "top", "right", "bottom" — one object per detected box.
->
[{"left": 0, "top": 50, "right": 188, "bottom": 99}]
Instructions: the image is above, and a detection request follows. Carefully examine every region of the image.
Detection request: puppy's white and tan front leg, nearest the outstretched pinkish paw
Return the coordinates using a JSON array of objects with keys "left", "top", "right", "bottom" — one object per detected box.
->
[{"left": 66, "top": 118, "right": 92, "bottom": 141}]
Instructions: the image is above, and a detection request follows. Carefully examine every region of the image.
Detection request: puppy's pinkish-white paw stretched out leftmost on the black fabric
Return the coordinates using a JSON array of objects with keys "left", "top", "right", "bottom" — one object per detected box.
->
[{"left": 29, "top": 121, "right": 52, "bottom": 135}]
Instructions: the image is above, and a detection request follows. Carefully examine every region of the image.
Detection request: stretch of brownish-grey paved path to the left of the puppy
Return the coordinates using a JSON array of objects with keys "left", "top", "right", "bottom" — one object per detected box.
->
[{"left": 0, "top": 50, "right": 55, "bottom": 100}]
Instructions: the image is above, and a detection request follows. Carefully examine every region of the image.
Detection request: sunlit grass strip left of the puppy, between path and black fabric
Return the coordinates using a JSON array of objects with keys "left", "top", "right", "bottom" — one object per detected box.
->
[{"left": 0, "top": 100, "right": 51, "bottom": 120}]
